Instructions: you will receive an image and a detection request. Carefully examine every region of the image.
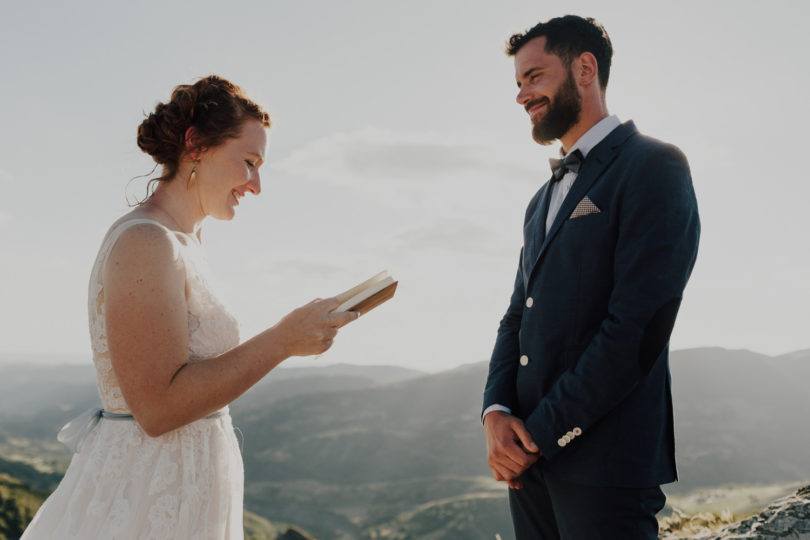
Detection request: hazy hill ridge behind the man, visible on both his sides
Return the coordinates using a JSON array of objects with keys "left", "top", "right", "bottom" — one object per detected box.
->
[{"left": 233, "top": 349, "right": 810, "bottom": 489}]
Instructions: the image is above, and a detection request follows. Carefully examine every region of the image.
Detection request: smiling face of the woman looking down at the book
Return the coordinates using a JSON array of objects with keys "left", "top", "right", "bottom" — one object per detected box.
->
[{"left": 192, "top": 118, "right": 267, "bottom": 220}]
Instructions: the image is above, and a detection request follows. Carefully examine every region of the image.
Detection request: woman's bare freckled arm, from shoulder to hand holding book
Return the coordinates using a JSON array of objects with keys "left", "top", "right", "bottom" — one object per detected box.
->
[{"left": 104, "top": 226, "right": 356, "bottom": 437}]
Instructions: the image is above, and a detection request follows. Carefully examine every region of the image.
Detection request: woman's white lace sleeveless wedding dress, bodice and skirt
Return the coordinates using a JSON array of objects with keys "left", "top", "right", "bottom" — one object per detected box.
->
[{"left": 22, "top": 219, "right": 244, "bottom": 540}]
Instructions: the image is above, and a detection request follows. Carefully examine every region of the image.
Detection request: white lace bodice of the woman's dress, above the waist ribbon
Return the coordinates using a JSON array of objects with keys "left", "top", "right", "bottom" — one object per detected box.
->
[{"left": 88, "top": 218, "right": 239, "bottom": 412}]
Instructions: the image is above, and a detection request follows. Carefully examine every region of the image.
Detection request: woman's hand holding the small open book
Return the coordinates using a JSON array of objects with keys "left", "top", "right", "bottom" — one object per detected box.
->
[{"left": 276, "top": 298, "right": 357, "bottom": 356}]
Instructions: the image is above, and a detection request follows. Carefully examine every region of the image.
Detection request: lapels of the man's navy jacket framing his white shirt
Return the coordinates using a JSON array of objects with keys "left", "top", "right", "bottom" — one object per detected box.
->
[{"left": 524, "top": 121, "right": 638, "bottom": 287}]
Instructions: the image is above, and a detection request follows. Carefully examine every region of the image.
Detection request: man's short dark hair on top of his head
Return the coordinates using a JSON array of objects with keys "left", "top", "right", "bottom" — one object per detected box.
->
[{"left": 506, "top": 15, "right": 613, "bottom": 90}]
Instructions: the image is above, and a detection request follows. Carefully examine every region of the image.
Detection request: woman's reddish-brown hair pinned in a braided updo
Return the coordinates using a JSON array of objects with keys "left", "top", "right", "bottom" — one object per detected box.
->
[{"left": 138, "top": 75, "right": 270, "bottom": 188}]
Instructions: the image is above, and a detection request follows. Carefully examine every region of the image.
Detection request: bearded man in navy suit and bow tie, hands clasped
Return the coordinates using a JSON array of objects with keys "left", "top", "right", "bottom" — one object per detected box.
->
[{"left": 483, "top": 15, "right": 700, "bottom": 540}]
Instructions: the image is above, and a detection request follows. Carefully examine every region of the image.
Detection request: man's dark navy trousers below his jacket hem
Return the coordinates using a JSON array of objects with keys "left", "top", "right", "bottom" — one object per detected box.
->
[{"left": 509, "top": 466, "right": 666, "bottom": 540}]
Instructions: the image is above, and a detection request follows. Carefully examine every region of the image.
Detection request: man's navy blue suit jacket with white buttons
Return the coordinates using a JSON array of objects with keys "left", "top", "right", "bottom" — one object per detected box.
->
[{"left": 484, "top": 122, "right": 700, "bottom": 487}]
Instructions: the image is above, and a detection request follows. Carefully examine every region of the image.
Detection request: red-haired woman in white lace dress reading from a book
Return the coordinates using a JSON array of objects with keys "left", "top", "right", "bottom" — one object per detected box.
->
[{"left": 22, "top": 76, "right": 357, "bottom": 540}]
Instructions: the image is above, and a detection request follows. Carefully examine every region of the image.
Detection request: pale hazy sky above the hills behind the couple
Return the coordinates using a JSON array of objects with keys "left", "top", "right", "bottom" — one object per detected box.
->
[{"left": 0, "top": 0, "right": 810, "bottom": 371}]
